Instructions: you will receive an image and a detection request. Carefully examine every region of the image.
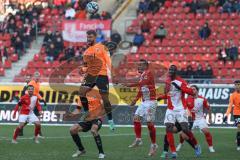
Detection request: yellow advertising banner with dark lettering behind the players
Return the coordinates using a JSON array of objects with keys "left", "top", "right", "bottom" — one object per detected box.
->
[{"left": 0, "top": 83, "right": 163, "bottom": 105}]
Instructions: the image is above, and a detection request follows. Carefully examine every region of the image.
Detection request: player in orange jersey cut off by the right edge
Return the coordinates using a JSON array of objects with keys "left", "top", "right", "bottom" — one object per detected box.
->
[{"left": 223, "top": 80, "right": 240, "bottom": 151}]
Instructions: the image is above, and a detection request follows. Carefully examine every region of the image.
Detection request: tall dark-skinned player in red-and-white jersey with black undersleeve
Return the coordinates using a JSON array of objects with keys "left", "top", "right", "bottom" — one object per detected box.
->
[{"left": 158, "top": 65, "right": 201, "bottom": 159}]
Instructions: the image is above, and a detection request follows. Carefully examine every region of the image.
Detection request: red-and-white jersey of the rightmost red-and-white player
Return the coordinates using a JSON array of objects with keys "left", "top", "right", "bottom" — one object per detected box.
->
[{"left": 187, "top": 96, "right": 210, "bottom": 120}]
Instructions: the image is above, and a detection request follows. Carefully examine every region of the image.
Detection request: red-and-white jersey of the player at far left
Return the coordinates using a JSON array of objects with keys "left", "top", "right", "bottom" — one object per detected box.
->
[{"left": 14, "top": 94, "right": 42, "bottom": 115}]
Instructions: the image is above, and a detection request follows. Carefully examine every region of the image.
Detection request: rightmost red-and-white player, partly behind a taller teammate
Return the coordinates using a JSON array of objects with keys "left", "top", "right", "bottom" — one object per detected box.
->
[{"left": 174, "top": 85, "right": 215, "bottom": 153}]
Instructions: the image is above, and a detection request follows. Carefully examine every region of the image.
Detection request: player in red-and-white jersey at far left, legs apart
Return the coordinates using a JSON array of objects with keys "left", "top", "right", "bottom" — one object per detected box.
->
[{"left": 12, "top": 85, "right": 42, "bottom": 144}]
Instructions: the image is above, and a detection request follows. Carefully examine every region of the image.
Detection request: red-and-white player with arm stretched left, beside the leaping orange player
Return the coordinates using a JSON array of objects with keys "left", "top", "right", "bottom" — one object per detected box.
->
[{"left": 125, "top": 59, "right": 158, "bottom": 156}]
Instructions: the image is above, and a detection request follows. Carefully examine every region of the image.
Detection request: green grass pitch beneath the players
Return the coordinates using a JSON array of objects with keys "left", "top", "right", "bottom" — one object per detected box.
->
[{"left": 0, "top": 125, "right": 240, "bottom": 160}]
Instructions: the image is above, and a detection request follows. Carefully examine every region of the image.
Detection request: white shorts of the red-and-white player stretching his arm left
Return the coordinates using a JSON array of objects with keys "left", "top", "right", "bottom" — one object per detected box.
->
[{"left": 135, "top": 101, "right": 157, "bottom": 122}]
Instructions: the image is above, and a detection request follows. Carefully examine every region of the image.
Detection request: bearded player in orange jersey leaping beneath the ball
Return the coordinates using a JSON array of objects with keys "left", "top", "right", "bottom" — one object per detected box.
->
[{"left": 80, "top": 30, "right": 115, "bottom": 130}]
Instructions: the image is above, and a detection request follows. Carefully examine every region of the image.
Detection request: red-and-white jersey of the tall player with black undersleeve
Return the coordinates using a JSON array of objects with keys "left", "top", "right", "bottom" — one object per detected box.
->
[{"left": 159, "top": 76, "right": 194, "bottom": 110}]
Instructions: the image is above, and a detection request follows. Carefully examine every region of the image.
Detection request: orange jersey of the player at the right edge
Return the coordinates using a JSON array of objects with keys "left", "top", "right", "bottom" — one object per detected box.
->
[{"left": 226, "top": 91, "right": 240, "bottom": 116}]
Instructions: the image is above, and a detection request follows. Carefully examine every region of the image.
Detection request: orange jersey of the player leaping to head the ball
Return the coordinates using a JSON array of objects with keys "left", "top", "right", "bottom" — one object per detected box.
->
[{"left": 83, "top": 43, "right": 111, "bottom": 76}]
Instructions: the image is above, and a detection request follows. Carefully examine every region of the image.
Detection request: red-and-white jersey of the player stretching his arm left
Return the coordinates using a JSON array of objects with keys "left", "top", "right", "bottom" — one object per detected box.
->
[{"left": 130, "top": 70, "right": 156, "bottom": 101}]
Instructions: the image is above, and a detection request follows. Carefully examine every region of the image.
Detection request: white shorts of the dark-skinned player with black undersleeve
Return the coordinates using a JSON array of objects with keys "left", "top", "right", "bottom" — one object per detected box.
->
[{"left": 164, "top": 109, "right": 188, "bottom": 124}]
